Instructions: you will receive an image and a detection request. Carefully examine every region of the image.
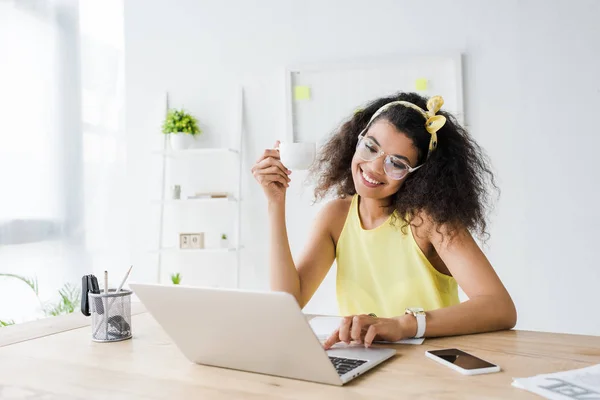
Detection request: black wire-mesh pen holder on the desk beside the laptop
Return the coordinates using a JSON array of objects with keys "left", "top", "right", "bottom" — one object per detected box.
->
[{"left": 88, "top": 289, "right": 133, "bottom": 342}]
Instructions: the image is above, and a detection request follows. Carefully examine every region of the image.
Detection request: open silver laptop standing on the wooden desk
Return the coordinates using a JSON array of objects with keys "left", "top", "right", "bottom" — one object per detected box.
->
[{"left": 129, "top": 283, "right": 396, "bottom": 386}]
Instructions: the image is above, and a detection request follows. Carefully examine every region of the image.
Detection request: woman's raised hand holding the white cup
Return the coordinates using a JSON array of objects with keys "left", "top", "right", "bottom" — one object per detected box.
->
[{"left": 252, "top": 141, "right": 292, "bottom": 203}]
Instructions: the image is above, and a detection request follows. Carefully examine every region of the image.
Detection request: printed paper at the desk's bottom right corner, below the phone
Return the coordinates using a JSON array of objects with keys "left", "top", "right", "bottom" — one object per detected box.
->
[{"left": 512, "top": 364, "right": 600, "bottom": 400}]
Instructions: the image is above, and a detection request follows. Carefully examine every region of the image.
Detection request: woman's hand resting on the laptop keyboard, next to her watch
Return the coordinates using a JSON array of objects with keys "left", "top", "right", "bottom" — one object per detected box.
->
[{"left": 323, "top": 314, "right": 410, "bottom": 350}]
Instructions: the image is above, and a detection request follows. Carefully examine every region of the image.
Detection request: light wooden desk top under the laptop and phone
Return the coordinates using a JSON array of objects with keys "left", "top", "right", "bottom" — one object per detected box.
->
[{"left": 0, "top": 306, "right": 600, "bottom": 400}]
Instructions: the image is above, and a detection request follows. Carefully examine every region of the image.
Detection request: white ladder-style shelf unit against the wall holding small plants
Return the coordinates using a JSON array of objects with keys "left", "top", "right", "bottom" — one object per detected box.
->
[{"left": 151, "top": 87, "right": 244, "bottom": 288}]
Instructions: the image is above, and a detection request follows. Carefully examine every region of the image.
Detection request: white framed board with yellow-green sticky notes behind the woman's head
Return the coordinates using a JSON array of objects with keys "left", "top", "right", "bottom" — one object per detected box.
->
[{"left": 285, "top": 54, "right": 464, "bottom": 146}]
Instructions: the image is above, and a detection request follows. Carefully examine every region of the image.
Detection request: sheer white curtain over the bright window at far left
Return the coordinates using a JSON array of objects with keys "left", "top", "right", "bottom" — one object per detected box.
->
[{"left": 0, "top": 0, "right": 129, "bottom": 322}]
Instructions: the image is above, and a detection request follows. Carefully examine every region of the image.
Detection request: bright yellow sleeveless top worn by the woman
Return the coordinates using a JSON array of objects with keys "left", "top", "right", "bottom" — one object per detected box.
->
[{"left": 336, "top": 195, "right": 459, "bottom": 318}]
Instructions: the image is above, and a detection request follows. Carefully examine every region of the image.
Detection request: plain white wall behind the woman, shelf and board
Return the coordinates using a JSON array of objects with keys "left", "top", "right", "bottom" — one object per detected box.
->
[{"left": 125, "top": 0, "right": 600, "bottom": 334}]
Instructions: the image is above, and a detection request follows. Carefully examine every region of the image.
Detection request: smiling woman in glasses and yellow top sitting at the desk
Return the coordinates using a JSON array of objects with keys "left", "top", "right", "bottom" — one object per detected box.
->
[{"left": 252, "top": 93, "right": 517, "bottom": 348}]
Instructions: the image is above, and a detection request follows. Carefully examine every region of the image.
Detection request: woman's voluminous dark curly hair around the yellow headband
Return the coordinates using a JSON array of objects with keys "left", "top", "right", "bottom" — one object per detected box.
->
[{"left": 310, "top": 93, "right": 498, "bottom": 238}]
